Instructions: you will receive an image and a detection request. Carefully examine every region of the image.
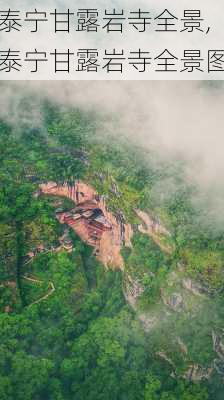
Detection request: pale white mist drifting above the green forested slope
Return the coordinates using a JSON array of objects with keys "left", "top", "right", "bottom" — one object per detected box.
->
[{"left": 0, "top": 81, "right": 224, "bottom": 225}]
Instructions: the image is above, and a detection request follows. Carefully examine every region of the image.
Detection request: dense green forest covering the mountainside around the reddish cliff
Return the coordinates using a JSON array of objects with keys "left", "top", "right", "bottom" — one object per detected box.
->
[{"left": 0, "top": 95, "right": 224, "bottom": 400}]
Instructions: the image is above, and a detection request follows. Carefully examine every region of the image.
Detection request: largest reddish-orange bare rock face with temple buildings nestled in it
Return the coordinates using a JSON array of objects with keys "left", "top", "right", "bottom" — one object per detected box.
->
[{"left": 40, "top": 181, "right": 133, "bottom": 269}]
